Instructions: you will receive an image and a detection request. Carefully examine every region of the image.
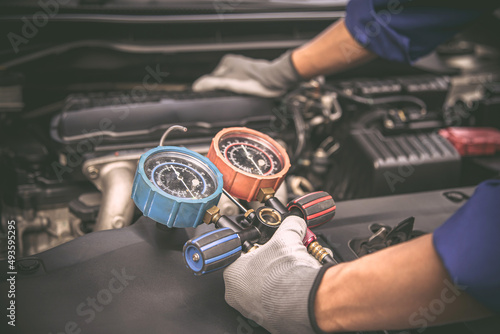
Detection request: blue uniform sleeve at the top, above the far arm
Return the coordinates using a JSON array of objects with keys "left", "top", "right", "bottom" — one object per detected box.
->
[{"left": 345, "top": 0, "right": 494, "bottom": 63}]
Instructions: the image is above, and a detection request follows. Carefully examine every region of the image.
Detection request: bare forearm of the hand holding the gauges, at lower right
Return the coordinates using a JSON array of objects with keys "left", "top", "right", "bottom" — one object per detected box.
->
[{"left": 315, "top": 235, "right": 490, "bottom": 331}]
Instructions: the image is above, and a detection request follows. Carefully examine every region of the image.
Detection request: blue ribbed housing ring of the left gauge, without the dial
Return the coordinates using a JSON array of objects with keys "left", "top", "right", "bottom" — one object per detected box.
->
[{"left": 132, "top": 146, "right": 223, "bottom": 228}]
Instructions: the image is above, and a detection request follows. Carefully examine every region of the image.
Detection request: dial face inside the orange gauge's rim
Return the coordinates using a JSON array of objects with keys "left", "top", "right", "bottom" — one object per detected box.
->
[{"left": 219, "top": 132, "right": 283, "bottom": 176}]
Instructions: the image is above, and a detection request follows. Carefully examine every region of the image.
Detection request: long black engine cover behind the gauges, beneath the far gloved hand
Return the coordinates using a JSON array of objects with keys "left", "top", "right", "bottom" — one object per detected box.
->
[{"left": 51, "top": 91, "right": 275, "bottom": 153}]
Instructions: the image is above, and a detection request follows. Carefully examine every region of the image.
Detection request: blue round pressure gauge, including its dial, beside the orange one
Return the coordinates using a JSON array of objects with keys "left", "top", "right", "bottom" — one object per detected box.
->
[{"left": 132, "top": 146, "right": 222, "bottom": 228}]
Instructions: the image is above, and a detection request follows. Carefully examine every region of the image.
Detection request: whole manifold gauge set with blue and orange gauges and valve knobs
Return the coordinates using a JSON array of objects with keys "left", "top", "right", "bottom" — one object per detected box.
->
[{"left": 132, "top": 125, "right": 335, "bottom": 275}]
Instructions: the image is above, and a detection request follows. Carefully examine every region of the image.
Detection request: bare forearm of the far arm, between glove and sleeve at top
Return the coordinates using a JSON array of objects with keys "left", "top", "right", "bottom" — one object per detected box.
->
[{"left": 292, "top": 19, "right": 376, "bottom": 79}]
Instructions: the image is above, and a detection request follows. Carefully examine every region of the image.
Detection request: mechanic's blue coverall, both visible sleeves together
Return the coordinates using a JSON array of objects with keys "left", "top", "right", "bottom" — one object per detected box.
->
[{"left": 345, "top": 0, "right": 500, "bottom": 313}]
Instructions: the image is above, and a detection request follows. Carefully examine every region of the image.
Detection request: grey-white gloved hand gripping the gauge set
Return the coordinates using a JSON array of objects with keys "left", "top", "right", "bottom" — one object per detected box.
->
[{"left": 224, "top": 216, "right": 321, "bottom": 334}]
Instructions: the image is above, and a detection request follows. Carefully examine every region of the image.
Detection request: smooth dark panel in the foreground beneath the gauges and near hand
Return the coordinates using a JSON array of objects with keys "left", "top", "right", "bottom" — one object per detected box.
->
[{"left": 0, "top": 188, "right": 500, "bottom": 334}]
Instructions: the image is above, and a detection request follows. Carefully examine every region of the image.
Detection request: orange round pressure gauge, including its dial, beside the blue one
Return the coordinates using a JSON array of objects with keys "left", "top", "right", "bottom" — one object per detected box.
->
[{"left": 207, "top": 127, "right": 290, "bottom": 202}]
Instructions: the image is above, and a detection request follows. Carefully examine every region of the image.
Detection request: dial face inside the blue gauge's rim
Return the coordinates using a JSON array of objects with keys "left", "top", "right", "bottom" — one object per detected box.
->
[{"left": 144, "top": 152, "right": 217, "bottom": 199}]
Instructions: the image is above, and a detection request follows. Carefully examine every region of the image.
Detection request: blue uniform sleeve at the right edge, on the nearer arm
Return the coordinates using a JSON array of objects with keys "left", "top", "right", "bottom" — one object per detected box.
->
[{"left": 433, "top": 180, "right": 500, "bottom": 313}]
